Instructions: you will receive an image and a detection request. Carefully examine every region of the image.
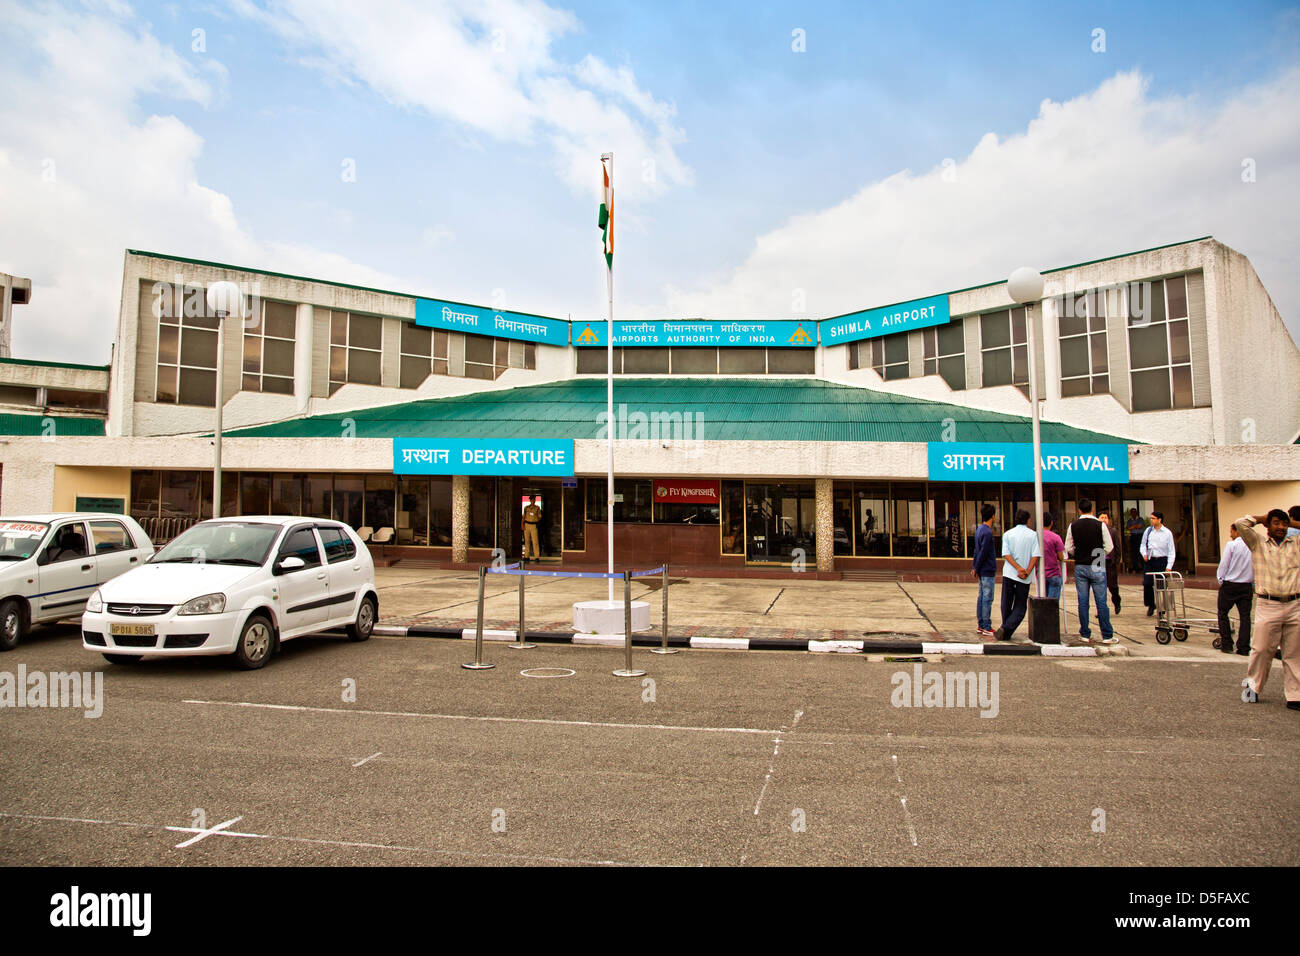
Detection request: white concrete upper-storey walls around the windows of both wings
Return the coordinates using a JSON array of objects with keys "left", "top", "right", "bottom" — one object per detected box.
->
[{"left": 108, "top": 238, "right": 1300, "bottom": 445}]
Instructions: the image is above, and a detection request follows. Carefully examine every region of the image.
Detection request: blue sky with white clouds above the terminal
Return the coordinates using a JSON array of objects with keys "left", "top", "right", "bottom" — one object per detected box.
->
[{"left": 0, "top": 0, "right": 1300, "bottom": 362}]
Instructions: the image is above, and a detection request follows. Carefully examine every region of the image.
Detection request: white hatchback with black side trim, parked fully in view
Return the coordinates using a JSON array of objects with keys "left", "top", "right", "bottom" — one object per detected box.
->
[{"left": 82, "top": 516, "right": 380, "bottom": 670}]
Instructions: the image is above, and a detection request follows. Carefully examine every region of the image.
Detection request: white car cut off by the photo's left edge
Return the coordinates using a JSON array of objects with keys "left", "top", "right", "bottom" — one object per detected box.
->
[{"left": 0, "top": 511, "right": 153, "bottom": 650}]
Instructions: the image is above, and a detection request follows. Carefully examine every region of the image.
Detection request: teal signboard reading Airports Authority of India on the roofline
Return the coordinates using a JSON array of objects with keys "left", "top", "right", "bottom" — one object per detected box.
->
[{"left": 573, "top": 319, "right": 816, "bottom": 349}]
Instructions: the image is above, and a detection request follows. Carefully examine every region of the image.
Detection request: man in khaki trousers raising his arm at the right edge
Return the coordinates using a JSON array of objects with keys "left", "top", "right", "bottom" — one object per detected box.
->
[{"left": 1235, "top": 509, "right": 1300, "bottom": 710}]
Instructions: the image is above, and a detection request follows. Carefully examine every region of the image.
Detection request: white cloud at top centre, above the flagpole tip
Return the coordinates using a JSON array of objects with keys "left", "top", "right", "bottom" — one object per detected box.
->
[{"left": 235, "top": 0, "right": 692, "bottom": 203}]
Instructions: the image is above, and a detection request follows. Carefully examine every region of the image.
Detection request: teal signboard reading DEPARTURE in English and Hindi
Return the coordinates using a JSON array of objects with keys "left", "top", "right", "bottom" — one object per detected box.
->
[{"left": 393, "top": 438, "right": 573, "bottom": 477}]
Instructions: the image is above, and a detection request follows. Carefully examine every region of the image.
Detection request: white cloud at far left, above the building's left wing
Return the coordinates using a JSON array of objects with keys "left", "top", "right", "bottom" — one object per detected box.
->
[{"left": 0, "top": 3, "right": 407, "bottom": 363}]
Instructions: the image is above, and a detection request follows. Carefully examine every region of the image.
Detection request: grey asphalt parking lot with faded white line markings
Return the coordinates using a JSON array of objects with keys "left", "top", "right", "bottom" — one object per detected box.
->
[{"left": 0, "top": 616, "right": 1300, "bottom": 866}]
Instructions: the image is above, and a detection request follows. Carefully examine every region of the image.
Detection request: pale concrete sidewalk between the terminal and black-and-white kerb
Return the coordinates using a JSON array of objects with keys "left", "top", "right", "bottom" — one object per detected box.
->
[{"left": 376, "top": 567, "right": 1244, "bottom": 658}]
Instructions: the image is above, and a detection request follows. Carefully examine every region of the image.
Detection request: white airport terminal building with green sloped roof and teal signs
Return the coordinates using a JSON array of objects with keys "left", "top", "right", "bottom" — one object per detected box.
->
[{"left": 0, "top": 237, "right": 1300, "bottom": 578}]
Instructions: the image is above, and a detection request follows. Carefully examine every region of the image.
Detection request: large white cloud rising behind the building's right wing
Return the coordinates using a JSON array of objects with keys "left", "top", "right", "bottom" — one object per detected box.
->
[{"left": 666, "top": 70, "right": 1300, "bottom": 338}]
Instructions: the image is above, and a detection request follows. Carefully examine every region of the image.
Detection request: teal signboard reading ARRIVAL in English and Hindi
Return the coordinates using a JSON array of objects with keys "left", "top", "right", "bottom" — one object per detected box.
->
[{"left": 928, "top": 441, "right": 1128, "bottom": 485}]
